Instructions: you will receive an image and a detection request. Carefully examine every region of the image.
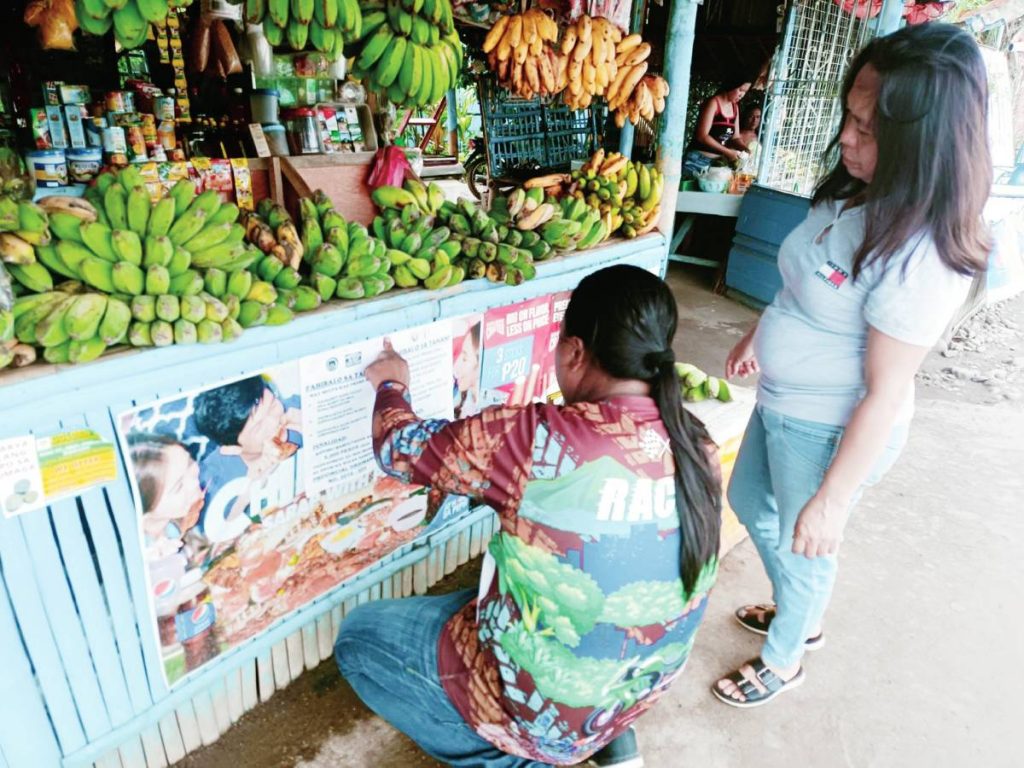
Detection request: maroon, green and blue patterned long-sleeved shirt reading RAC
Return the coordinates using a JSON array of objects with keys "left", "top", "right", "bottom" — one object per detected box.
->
[{"left": 374, "top": 384, "right": 717, "bottom": 765}]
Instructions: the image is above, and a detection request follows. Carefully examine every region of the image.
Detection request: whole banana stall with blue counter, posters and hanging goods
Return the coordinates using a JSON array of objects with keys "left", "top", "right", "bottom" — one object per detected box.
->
[{"left": 0, "top": 0, "right": 751, "bottom": 768}]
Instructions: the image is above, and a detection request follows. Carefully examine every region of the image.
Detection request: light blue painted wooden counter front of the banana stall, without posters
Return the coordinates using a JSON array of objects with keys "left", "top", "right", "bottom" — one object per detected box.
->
[{"left": 0, "top": 233, "right": 667, "bottom": 768}]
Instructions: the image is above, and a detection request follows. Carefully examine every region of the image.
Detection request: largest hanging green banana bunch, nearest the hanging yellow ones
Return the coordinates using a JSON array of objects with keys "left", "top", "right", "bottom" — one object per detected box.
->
[{"left": 345, "top": 0, "right": 463, "bottom": 106}]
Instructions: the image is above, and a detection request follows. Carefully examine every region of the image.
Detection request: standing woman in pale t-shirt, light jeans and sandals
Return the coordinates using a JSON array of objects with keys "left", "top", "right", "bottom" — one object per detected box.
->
[{"left": 712, "top": 24, "right": 992, "bottom": 708}]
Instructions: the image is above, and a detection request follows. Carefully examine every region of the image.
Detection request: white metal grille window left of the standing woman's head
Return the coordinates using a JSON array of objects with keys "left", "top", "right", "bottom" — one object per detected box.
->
[{"left": 758, "top": 0, "right": 876, "bottom": 197}]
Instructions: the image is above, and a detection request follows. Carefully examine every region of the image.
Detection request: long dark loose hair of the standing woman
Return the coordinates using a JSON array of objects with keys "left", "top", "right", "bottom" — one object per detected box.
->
[{"left": 813, "top": 23, "right": 992, "bottom": 278}]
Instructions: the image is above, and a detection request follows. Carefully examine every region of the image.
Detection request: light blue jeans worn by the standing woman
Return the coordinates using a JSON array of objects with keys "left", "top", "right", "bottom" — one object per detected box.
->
[{"left": 728, "top": 404, "right": 907, "bottom": 668}]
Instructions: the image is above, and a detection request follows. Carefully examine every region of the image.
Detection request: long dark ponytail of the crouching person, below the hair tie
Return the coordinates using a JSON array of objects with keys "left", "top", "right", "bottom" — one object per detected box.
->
[{"left": 651, "top": 362, "right": 722, "bottom": 594}]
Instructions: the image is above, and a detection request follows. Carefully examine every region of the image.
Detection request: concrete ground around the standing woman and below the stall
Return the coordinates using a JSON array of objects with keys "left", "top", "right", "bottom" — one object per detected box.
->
[{"left": 180, "top": 266, "right": 1024, "bottom": 768}]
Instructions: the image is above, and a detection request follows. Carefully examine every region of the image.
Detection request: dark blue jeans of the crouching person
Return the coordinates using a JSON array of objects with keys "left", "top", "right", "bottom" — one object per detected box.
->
[{"left": 334, "top": 590, "right": 547, "bottom": 768}]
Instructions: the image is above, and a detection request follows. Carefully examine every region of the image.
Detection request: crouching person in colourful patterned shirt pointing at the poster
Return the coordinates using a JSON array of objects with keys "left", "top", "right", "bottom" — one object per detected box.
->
[{"left": 335, "top": 266, "right": 721, "bottom": 768}]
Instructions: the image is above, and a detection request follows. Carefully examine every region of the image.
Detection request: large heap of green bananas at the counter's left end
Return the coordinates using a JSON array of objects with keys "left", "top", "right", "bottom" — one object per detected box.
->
[{"left": 0, "top": 166, "right": 319, "bottom": 362}]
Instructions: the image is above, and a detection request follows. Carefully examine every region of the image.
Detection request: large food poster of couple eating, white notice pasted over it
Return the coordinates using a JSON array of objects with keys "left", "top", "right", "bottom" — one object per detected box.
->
[{"left": 118, "top": 322, "right": 456, "bottom": 685}]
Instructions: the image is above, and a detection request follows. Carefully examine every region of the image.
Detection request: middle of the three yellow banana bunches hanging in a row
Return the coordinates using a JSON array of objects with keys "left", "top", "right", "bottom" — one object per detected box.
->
[{"left": 560, "top": 14, "right": 622, "bottom": 110}]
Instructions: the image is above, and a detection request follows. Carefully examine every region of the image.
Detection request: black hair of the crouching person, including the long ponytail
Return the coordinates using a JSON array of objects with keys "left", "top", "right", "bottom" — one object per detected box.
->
[{"left": 562, "top": 265, "right": 722, "bottom": 591}]
